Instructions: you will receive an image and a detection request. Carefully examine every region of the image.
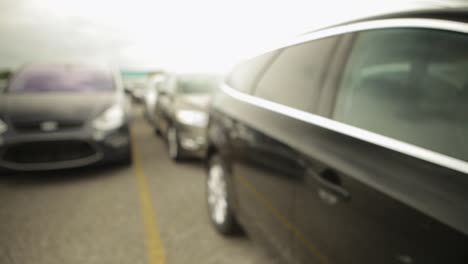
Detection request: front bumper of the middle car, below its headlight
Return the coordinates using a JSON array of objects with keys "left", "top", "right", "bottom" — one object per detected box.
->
[{"left": 176, "top": 122, "right": 208, "bottom": 158}]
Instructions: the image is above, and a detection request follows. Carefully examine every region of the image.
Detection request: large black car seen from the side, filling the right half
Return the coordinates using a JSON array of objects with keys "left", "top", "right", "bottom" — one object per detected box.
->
[{"left": 207, "top": 9, "right": 468, "bottom": 264}]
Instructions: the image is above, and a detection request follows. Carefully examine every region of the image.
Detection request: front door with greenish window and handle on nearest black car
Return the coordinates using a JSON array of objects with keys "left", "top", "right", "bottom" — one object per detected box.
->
[{"left": 294, "top": 23, "right": 468, "bottom": 263}]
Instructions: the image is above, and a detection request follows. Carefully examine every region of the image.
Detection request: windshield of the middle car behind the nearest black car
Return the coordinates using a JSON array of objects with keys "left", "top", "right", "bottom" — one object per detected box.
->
[{"left": 177, "top": 75, "right": 218, "bottom": 94}]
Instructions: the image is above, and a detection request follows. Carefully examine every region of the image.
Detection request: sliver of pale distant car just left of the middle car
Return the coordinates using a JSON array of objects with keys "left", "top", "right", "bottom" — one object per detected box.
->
[{"left": 143, "top": 74, "right": 167, "bottom": 126}]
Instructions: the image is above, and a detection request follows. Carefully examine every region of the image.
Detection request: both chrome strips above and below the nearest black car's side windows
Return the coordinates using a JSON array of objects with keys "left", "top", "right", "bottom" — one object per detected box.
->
[{"left": 225, "top": 18, "right": 468, "bottom": 174}]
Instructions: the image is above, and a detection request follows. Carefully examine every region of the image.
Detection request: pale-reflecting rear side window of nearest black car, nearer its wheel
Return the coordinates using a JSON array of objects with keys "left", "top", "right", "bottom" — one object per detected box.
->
[{"left": 255, "top": 37, "right": 336, "bottom": 110}]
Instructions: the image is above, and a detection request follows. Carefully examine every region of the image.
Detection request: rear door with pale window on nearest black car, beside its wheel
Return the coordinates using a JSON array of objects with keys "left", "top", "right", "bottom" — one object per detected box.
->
[{"left": 227, "top": 38, "right": 337, "bottom": 261}]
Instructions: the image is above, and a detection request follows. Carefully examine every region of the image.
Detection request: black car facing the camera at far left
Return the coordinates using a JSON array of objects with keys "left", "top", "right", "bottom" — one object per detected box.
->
[{"left": 0, "top": 64, "right": 131, "bottom": 170}]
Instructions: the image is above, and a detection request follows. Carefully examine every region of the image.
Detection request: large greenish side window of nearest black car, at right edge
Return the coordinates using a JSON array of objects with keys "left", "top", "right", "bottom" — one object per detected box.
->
[{"left": 334, "top": 28, "right": 468, "bottom": 161}]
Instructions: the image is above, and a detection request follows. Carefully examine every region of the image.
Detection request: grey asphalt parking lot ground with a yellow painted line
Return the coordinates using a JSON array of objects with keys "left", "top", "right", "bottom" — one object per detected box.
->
[{"left": 0, "top": 106, "right": 275, "bottom": 264}]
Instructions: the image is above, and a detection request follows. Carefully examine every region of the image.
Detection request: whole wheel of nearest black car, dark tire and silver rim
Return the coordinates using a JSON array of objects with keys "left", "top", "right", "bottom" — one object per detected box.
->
[{"left": 206, "top": 155, "right": 241, "bottom": 236}]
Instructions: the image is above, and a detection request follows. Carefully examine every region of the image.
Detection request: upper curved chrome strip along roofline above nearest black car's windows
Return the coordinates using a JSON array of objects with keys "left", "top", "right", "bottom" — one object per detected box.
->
[{"left": 250, "top": 18, "right": 468, "bottom": 60}]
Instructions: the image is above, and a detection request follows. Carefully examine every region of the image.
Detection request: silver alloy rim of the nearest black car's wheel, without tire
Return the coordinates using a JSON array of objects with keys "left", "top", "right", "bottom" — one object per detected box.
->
[{"left": 207, "top": 164, "right": 228, "bottom": 224}]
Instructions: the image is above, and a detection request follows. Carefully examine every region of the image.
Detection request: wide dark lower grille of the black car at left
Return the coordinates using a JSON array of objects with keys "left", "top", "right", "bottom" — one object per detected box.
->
[{"left": 3, "top": 140, "right": 96, "bottom": 163}]
